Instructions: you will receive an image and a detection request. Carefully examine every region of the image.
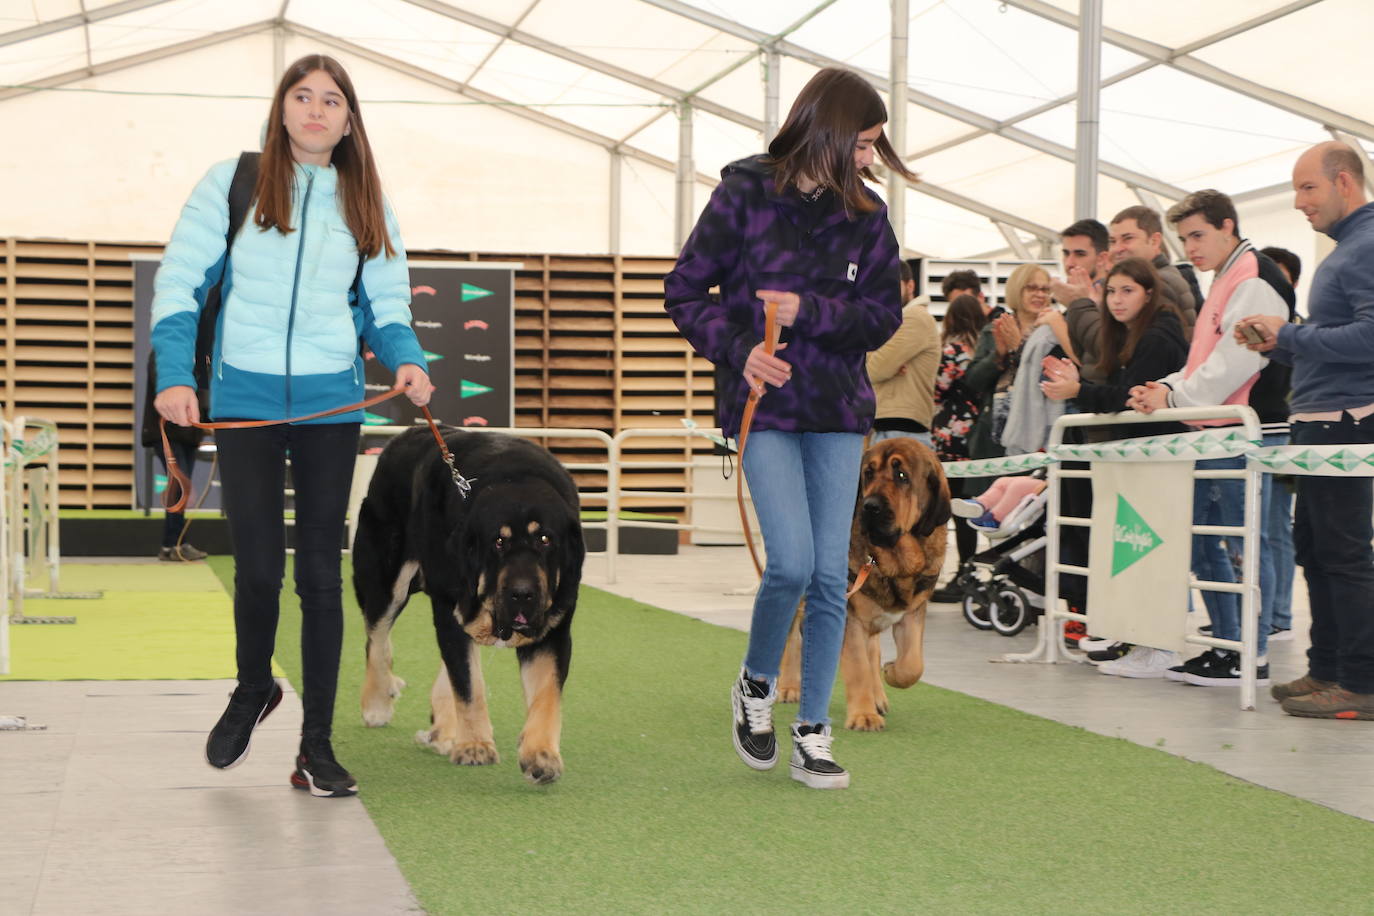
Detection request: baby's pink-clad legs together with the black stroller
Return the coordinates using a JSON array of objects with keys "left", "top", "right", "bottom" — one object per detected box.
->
[{"left": 952, "top": 470, "right": 1048, "bottom": 636}]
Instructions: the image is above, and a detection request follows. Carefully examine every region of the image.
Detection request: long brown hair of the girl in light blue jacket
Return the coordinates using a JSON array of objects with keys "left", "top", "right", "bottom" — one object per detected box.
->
[{"left": 253, "top": 54, "right": 396, "bottom": 258}]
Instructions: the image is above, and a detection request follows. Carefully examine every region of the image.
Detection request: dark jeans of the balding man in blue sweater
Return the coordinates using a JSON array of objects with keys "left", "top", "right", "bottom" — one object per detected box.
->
[{"left": 1293, "top": 413, "right": 1374, "bottom": 694}]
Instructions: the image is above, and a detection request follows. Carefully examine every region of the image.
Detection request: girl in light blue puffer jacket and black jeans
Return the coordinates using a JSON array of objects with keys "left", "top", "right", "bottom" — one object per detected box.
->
[{"left": 153, "top": 55, "right": 433, "bottom": 797}]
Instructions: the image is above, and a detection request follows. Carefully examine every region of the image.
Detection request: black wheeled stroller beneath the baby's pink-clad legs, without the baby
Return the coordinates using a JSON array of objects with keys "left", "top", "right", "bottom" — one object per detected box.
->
[{"left": 954, "top": 480, "right": 1050, "bottom": 636}]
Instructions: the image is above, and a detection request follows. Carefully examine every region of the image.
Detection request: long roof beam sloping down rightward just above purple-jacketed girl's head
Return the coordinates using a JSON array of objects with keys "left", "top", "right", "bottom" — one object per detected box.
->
[{"left": 640, "top": 0, "right": 1187, "bottom": 201}]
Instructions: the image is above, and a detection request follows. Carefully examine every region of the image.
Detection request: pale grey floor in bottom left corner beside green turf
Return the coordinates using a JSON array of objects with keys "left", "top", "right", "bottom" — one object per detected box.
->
[{"left": 0, "top": 681, "right": 422, "bottom": 916}]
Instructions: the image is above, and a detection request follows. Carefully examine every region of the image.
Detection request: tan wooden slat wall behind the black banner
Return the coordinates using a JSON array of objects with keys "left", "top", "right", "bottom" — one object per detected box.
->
[{"left": 0, "top": 239, "right": 714, "bottom": 516}]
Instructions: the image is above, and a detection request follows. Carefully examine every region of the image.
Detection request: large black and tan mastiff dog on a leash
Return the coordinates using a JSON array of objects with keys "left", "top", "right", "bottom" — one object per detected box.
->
[{"left": 353, "top": 427, "right": 585, "bottom": 784}]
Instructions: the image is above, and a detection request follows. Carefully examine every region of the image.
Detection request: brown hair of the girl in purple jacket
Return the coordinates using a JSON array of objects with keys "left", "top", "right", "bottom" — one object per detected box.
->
[{"left": 768, "top": 67, "right": 919, "bottom": 213}]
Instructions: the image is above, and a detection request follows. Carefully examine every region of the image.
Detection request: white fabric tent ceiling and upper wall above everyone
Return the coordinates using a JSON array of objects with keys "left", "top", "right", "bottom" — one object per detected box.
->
[{"left": 0, "top": 0, "right": 1374, "bottom": 265}]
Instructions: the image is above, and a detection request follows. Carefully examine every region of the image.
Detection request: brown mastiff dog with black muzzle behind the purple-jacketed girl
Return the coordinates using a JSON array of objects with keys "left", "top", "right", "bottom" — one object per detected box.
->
[{"left": 778, "top": 437, "right": 949, "bottom": 732}]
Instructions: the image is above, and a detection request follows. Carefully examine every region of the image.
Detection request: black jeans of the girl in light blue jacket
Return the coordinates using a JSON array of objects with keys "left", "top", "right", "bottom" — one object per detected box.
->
[{"left": 214, "top": 423, "right": 359, "bottom": 737}]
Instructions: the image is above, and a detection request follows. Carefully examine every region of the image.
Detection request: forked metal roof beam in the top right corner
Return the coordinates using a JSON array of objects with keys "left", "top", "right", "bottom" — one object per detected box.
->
[{"left": 999, "top": 0, "right": 1374, "bottom": 140}]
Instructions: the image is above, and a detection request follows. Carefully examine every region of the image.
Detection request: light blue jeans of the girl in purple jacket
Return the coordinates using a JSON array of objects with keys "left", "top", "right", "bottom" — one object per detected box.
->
[{"left": 743, "top": 430, "right": 863, "bottom": 725}]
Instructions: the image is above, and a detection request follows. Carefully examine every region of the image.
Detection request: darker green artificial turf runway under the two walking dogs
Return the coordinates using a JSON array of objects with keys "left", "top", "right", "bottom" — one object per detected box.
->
[{"left": 203, "top": 558, "right": 1374, "bottom": 916}]
